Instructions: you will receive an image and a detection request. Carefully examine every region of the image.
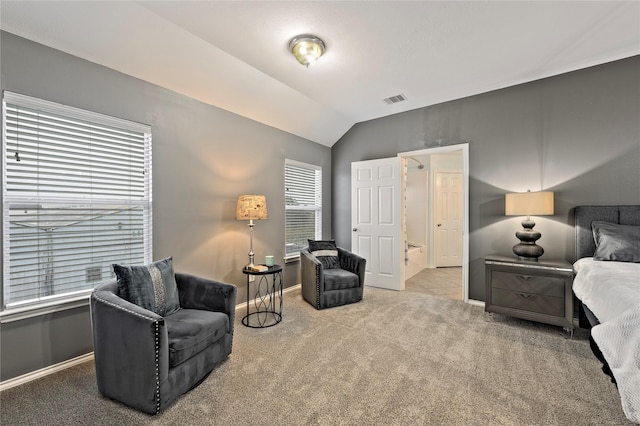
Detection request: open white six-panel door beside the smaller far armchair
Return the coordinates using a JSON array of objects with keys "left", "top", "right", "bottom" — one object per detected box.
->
[{"left": 351, "top": 157, "right": 404, "bottom": 290}]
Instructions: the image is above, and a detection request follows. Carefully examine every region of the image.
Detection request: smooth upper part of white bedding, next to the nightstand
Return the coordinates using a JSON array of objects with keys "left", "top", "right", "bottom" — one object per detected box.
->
[{"left": 573, "top": 257, "right": 640, "bottom": 323}]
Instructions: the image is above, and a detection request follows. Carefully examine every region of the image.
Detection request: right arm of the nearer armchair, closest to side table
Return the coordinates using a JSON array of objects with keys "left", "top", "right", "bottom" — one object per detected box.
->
[{"left": 175, "top": 272, "right": 237, "bottom": 333}]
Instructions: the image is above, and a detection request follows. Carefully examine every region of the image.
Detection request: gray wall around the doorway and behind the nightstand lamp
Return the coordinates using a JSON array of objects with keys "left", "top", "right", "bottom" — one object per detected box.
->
[{"left": 331, "top": 56, "right": 640, "bottom": 300}]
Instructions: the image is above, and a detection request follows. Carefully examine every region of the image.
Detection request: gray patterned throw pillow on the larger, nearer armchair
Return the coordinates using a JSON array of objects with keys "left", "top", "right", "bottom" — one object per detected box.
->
[{"left": 113, "top": 257, "right": 180, "bottom": 316}]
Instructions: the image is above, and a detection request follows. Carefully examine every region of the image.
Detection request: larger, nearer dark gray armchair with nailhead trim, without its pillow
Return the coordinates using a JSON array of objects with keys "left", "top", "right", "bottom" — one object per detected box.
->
[{"left": 91, "top": 273, "right": 237, "bottom": 414}]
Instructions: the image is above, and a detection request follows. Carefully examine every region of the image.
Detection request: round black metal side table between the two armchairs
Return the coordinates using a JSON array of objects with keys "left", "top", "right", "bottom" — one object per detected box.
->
[{"left": 242, "top": 265, "right": 282, "bottom": 328}]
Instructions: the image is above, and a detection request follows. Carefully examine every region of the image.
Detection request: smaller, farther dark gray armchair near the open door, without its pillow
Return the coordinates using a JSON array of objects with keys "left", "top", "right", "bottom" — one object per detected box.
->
[{"left": 300, "top": 247, "right": 366, "bottom": 309}]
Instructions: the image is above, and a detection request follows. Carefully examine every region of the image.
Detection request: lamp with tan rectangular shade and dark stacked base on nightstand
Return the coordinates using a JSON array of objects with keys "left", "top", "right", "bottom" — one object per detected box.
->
[{"left": 504, "top": 191, "right": 553, "bottom": 261}]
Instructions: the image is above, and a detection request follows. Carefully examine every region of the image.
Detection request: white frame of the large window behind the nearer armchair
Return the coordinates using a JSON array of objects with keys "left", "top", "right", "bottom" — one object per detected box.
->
[{"left": 0, "top": 90, "right": 153, "bottom": 323}]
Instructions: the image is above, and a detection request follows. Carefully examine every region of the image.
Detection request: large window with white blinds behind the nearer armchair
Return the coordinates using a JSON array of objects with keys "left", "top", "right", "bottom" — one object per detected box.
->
[{"left": 2, "top": 91, "right": 151, "bottom": 309}]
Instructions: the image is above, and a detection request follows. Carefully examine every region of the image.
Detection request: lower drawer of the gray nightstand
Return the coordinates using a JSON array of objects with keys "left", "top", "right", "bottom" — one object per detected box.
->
[{"left": 491, "top": 287, "right": 565, "bottom": 317}]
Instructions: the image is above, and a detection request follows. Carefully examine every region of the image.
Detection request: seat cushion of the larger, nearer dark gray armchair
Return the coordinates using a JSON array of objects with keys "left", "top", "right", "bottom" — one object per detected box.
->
[{"left": 164, "top": 309, "right": 229, "bottom": 368}]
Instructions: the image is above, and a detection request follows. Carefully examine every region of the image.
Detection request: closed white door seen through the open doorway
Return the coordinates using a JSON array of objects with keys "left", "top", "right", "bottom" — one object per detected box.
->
[{"left": 435, "top": 172, "right": 463, "bottom": 267}]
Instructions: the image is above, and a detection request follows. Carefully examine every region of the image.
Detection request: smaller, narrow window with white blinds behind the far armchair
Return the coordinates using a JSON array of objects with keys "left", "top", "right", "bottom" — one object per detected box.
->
[{"left": 284, "top": 160, "right": 322, "bottom": 257}]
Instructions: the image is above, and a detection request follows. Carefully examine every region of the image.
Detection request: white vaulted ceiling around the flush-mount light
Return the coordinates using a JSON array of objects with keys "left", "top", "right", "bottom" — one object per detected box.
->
[{"left": 0, "top": 0, "right": 640, "bottom": 146}]
